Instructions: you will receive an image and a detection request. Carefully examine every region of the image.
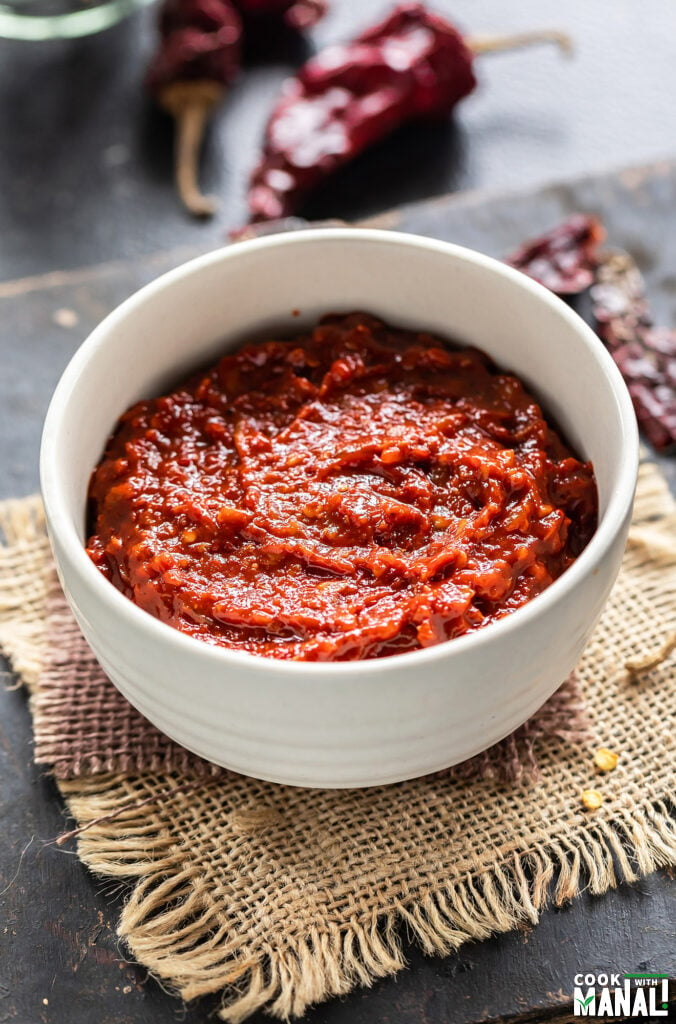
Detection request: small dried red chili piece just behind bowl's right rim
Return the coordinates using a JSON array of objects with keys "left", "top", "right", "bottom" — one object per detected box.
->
[{"left": 505, "top": 213, "right": 605, "bottom": 295}]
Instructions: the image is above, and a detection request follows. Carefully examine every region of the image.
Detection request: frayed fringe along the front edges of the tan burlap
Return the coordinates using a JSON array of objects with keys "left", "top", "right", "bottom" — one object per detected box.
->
[{"left": 60, "top": 776, "right": 676, "bottom": 1024}]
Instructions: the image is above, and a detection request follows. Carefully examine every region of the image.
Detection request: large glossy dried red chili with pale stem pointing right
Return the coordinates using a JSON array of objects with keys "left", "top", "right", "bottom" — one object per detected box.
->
[{"left": 249, "top": 3, "right": 568, "bottom": 221}]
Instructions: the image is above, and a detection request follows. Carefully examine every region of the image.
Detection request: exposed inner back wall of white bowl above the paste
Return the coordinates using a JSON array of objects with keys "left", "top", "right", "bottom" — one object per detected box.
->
[{"left": 42, "top": 229, "right": 633, "bottom": 541}]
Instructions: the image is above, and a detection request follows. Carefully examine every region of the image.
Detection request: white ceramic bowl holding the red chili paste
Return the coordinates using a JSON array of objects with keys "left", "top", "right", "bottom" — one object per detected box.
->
[{"left": 41, "top": 228, "right": 638, "bottom": 786}]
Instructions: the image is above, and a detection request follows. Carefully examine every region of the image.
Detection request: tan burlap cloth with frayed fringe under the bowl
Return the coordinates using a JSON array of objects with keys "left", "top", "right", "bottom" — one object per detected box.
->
[{"left": 0, "top": 464, "right": 676, "bottom": 1022}]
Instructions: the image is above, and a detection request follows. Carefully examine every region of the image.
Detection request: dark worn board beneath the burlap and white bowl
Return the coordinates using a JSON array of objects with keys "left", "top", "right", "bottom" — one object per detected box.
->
[{"left": 0, "top": 163, "right": 676, "bottom": 1024}]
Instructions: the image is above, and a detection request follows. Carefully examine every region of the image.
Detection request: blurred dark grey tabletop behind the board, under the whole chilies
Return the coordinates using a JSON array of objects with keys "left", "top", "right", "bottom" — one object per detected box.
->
[{"left": 0, "top": 0, "right": 676, "bottom": 280}]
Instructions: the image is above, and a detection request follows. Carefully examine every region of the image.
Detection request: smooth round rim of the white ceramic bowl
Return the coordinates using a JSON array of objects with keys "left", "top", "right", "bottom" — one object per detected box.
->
[{"left": 40, "top": 227, "right": 639, "bottom": 679}]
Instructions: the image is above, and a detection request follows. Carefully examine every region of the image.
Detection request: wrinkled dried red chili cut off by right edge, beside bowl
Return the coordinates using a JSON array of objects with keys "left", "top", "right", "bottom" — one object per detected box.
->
[{"left": 591, "top": 251, "right": 676, "bottom": 452}]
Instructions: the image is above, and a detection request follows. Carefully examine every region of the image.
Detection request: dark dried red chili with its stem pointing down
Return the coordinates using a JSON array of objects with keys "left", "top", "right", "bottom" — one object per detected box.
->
[{"left": 146, "top": 0, "right": 242, "bottom": 216}]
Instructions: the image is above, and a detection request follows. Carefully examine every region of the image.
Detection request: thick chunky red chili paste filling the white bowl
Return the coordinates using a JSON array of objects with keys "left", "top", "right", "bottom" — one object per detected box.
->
[{"left": 87, "top": 313, "right": 597, "bottom": 660}]
